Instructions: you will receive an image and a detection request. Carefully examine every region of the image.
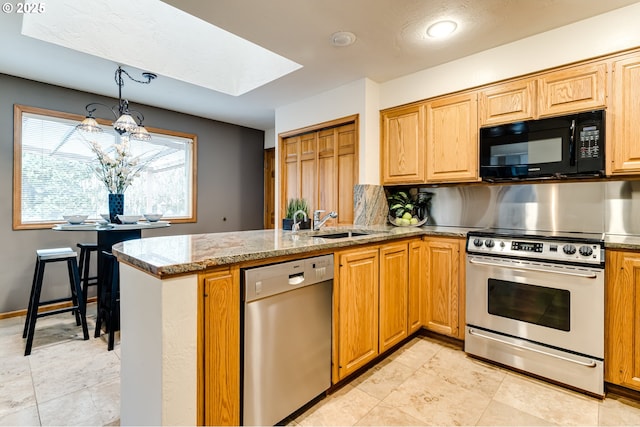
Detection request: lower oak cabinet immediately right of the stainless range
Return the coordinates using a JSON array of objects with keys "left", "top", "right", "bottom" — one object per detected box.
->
[{"left": 604, "top": 250, "right": 640, "bottom": 390}]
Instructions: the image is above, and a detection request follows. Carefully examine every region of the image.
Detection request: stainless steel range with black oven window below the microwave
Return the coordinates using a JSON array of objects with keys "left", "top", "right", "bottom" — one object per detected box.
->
[{"left": 465, "top": 229, "right": 604, "bottom": 396}]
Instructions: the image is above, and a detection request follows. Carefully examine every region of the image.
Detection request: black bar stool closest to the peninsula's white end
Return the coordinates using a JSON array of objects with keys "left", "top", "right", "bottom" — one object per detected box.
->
[{"left": 94, "top": 251, "right": 120, "bottom": 351}]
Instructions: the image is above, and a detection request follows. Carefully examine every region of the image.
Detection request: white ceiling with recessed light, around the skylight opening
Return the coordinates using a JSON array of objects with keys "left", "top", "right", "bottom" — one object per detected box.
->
[{"left": 0, "top": 0, "right": 638, "bottom": 130}]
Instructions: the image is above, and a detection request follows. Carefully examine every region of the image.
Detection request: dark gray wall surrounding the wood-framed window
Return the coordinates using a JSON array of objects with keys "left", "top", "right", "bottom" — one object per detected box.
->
[{"left": 0, "top": 74, "right": 264, "bottom": 313}]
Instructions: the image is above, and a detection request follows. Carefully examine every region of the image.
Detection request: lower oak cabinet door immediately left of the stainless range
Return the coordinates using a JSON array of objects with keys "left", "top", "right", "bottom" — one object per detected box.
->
[{"left": 423, "top": 238, "right": 461, "bottom": 337}]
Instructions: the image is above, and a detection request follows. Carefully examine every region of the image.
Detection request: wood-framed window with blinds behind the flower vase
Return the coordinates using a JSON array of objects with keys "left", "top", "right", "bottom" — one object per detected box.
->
[{"left": 13, "top": 105, "right": 197, "bottom": 229}]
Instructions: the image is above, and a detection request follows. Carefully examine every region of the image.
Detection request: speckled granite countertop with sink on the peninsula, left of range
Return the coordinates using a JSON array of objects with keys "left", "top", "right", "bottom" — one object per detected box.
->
[{"left": 113, "top": 225, "right": 470, "bottom": 278}]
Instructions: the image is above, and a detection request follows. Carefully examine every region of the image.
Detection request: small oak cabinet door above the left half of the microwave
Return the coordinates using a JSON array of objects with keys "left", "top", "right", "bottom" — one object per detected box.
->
[{"left": 478, "top": 79, "right": 536, "bottom": 126}]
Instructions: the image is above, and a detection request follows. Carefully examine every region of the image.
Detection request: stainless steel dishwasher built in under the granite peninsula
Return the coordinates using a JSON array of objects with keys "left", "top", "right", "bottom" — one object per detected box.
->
[{"left": 242, "top": 255, "right": 333, "bottom": 426}]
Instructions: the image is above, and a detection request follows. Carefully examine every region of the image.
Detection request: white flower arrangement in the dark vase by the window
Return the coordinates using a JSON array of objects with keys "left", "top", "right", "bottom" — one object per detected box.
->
[{"left": 89, "top": 138, "right": 146, "bottom": 194}]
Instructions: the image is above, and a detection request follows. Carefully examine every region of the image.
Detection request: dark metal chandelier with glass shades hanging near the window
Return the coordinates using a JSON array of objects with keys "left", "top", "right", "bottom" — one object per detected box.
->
[{"left": 76, "top": 67, "right": 157, "bottom": 141}]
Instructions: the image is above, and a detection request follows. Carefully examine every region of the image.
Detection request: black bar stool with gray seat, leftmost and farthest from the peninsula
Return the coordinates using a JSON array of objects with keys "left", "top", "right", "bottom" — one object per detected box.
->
[{"left": 22, "top": 248, "right": 89, "bottom": 356}]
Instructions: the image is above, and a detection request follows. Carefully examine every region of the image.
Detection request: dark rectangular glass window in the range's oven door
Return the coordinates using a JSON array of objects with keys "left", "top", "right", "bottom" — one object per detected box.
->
[{"left": 488, "top": 279, "right": 571, "bottom": 331}]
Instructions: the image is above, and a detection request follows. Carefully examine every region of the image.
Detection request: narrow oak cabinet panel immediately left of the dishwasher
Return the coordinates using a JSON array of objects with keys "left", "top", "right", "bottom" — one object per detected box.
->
[{"left": 198, "top": 267, "right": 240, "bottom": 426}]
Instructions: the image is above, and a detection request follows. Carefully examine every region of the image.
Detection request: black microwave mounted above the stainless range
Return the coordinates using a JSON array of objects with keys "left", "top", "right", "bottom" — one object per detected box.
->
[{"left": 480, "top": 110, "right": 605, "bottom": 181}]
